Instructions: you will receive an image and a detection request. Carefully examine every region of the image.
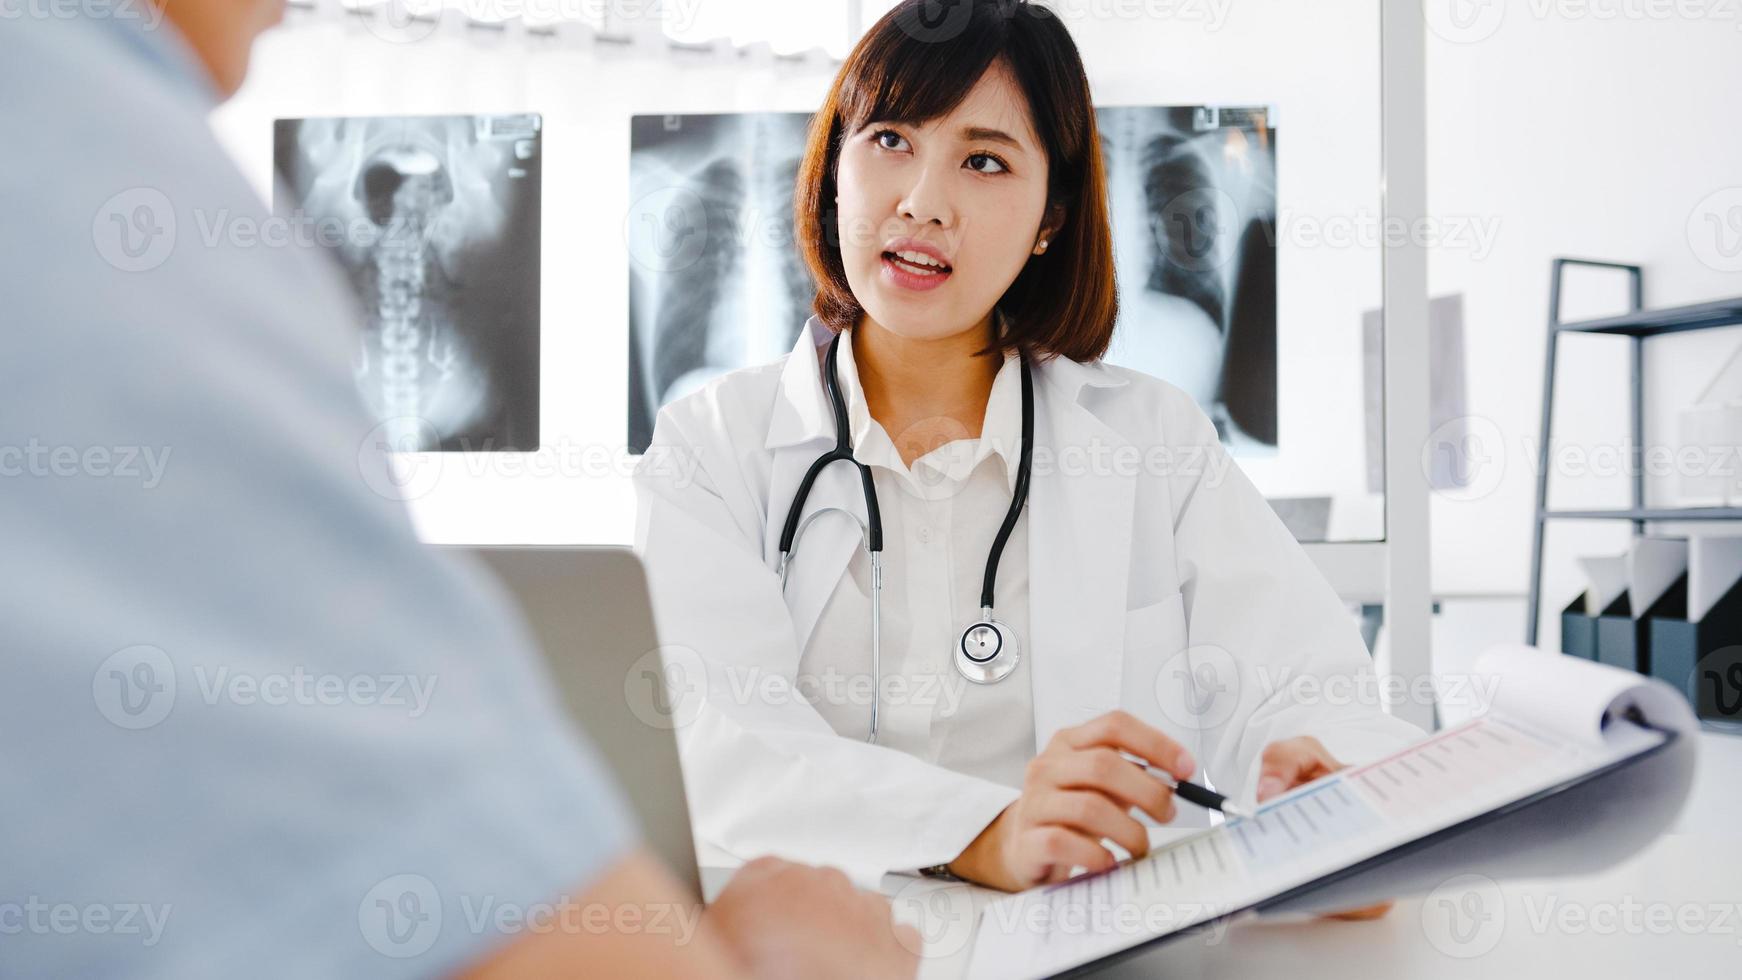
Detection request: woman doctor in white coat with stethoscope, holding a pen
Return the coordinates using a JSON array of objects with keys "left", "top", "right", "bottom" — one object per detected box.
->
[{"left": 636, "top": 0, "right": 1421, "bottom": 916}]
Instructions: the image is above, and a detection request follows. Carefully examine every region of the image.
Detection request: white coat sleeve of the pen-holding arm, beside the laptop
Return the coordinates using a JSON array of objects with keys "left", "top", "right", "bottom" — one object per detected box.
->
[{"left": 634, "top": 402, "right": 1019, "bottom": 886}]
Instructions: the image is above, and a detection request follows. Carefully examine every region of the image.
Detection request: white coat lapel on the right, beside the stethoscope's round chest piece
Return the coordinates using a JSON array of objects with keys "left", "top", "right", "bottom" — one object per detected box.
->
[{"left": 1024, "top": 357, "right": 1136, "bottom": 752}]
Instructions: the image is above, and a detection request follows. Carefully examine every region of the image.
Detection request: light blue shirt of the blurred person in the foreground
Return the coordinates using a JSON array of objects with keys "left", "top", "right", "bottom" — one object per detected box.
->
[{"left": 0, "top": 13, "right": 632, "bottom": 978}]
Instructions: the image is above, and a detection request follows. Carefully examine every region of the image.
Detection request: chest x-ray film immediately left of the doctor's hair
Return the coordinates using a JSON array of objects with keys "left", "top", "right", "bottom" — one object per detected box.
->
[{"left": 625, "top": 113, "right": 815, "bottom": 453}]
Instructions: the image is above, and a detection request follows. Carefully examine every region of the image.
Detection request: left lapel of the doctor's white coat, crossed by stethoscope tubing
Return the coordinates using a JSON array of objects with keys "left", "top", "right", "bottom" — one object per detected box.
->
[{"left": 763, "top": 317, "right": 866, "bottom": 649}]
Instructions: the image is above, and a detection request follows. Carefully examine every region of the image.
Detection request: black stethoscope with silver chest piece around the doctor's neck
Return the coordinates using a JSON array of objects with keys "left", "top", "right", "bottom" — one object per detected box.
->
[{"left": 779, "top": 334, "right": 1035, "bottom": 742}]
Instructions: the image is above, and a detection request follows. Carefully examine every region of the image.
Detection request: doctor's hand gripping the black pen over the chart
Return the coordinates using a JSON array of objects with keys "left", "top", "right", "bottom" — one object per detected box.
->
[{"left": 949, "top": 712, "right": 1197, "bottom": 891}]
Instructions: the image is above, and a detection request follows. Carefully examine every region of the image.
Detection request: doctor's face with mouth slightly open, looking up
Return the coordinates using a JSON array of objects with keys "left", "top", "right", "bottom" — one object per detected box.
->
[{"left": 836, "top": 63, "right": 1061, "bottom": 339}]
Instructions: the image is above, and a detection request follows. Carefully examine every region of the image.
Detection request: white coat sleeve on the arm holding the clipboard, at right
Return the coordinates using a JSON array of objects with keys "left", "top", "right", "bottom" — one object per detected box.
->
[{"left": 1172, "top": 395, "right": 1423, "bottom": 802}]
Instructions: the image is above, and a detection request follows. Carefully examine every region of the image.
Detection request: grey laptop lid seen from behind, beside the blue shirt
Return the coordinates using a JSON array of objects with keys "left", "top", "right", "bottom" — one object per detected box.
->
[{"left": 453, "top": 547, "right": 702, "bottom": 900}]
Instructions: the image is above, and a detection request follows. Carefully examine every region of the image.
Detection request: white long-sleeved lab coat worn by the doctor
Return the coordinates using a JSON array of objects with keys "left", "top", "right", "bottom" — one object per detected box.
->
[{"left": 634, "top": 317, "right": 1421, "bottom": 884}]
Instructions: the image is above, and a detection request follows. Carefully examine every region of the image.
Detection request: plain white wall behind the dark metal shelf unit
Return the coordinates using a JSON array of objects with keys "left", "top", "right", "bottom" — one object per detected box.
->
[{"left": 1428, "top": 0, "right": 1742, "bottom": 646}]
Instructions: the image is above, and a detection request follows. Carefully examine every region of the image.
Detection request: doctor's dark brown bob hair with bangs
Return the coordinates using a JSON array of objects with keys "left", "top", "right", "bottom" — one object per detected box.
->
[{"left": 793, "top": 0, "right": 1118, "bottom": 360}]
